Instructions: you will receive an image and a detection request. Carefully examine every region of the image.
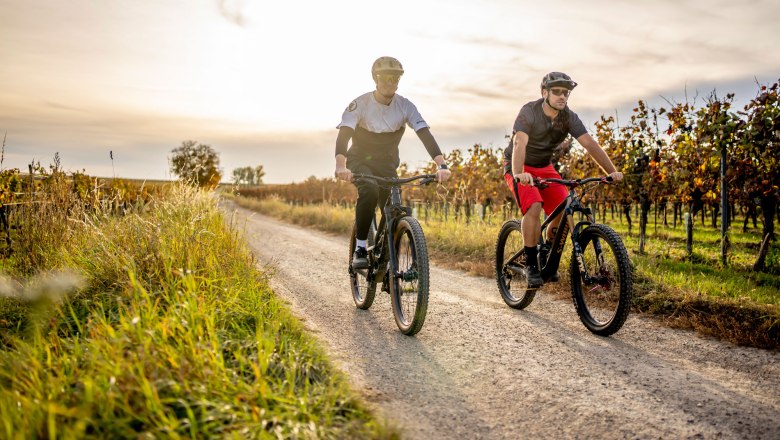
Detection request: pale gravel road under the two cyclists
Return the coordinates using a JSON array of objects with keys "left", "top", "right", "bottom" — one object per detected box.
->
[{"left": 227, "top": 206, "right": 780, "bottom": 440}]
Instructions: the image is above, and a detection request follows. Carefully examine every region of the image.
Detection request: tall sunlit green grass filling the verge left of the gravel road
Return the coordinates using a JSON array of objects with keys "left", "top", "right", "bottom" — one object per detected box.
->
[{"left": 0, "top": 186, "right": 390, "bottom": 439}]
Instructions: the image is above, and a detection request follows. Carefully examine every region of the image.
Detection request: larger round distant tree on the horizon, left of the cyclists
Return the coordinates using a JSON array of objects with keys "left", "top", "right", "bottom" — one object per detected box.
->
[{"left": 171, "top": 140, "right": 222, "bottom": 188}]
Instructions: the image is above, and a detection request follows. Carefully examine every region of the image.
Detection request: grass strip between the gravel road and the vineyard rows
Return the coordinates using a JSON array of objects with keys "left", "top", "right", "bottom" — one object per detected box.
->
[{"left": 236, "top": 197, "right": 780, "bottom": 348}]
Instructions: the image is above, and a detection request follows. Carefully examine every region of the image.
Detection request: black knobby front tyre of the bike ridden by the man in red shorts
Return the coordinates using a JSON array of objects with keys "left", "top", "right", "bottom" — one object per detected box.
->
[{"left": 571, "top": 224, "right": 633, "bottom": 336}]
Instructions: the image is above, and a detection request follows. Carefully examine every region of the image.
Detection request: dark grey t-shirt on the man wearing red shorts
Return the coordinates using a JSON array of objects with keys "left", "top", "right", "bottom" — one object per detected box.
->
[{"left": 504, "top": 98, "right": 588, "bottom": 173}]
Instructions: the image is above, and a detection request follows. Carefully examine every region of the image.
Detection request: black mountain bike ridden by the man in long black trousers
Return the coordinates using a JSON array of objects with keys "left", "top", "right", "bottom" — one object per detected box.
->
[{"left": 349, "top": 174, "right": 436, "bottom": 336}]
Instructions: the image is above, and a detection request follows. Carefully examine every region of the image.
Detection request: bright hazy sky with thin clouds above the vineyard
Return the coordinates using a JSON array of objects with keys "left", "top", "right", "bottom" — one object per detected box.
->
[{"left": 0, "top": 0, "right": 780, "bottom": 183}]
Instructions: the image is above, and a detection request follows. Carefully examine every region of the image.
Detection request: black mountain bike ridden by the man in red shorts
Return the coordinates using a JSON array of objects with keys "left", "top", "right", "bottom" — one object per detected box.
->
[{"left": 496, "top": 177, "right": 633, "bottom": 336}]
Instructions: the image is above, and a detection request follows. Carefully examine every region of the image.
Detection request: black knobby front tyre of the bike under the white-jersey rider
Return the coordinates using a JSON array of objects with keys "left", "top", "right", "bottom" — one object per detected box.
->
[{"left": 389, "top": 216, "right": 430, "bottom": 336}]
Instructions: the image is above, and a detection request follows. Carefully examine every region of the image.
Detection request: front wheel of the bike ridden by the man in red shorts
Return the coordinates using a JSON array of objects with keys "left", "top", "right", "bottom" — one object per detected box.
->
[{"left": 571, "top": 224, "right": 633, "bottom": 336}]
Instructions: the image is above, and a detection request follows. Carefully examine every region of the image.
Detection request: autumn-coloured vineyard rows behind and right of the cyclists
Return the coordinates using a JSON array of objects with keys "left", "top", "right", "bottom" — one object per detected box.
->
[{"left": 242, "top": 82, "right": 780, "bottom": 268}]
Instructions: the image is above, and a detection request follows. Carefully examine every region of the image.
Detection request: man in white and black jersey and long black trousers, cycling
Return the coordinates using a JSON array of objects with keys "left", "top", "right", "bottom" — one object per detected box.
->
[{"left": 336, "top": 57, "right": 451, "bottom": 269}]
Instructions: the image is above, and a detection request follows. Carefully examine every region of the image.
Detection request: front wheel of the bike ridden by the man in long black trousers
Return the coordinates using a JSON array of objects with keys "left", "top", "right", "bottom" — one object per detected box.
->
[{"left": 390, "top": 216, "right": 429, "bottom": 336}]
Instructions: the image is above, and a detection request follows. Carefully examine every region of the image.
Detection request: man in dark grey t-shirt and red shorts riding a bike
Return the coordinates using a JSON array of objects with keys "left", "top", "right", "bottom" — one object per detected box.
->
[{"left": 504, "top": 72, "right": 623, "bottom": 289}]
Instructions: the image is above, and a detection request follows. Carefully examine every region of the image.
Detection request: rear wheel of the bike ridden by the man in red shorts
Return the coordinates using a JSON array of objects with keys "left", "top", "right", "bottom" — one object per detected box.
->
[{"left": 496, "top": 220, "right": 536, "bottom": 309}]
